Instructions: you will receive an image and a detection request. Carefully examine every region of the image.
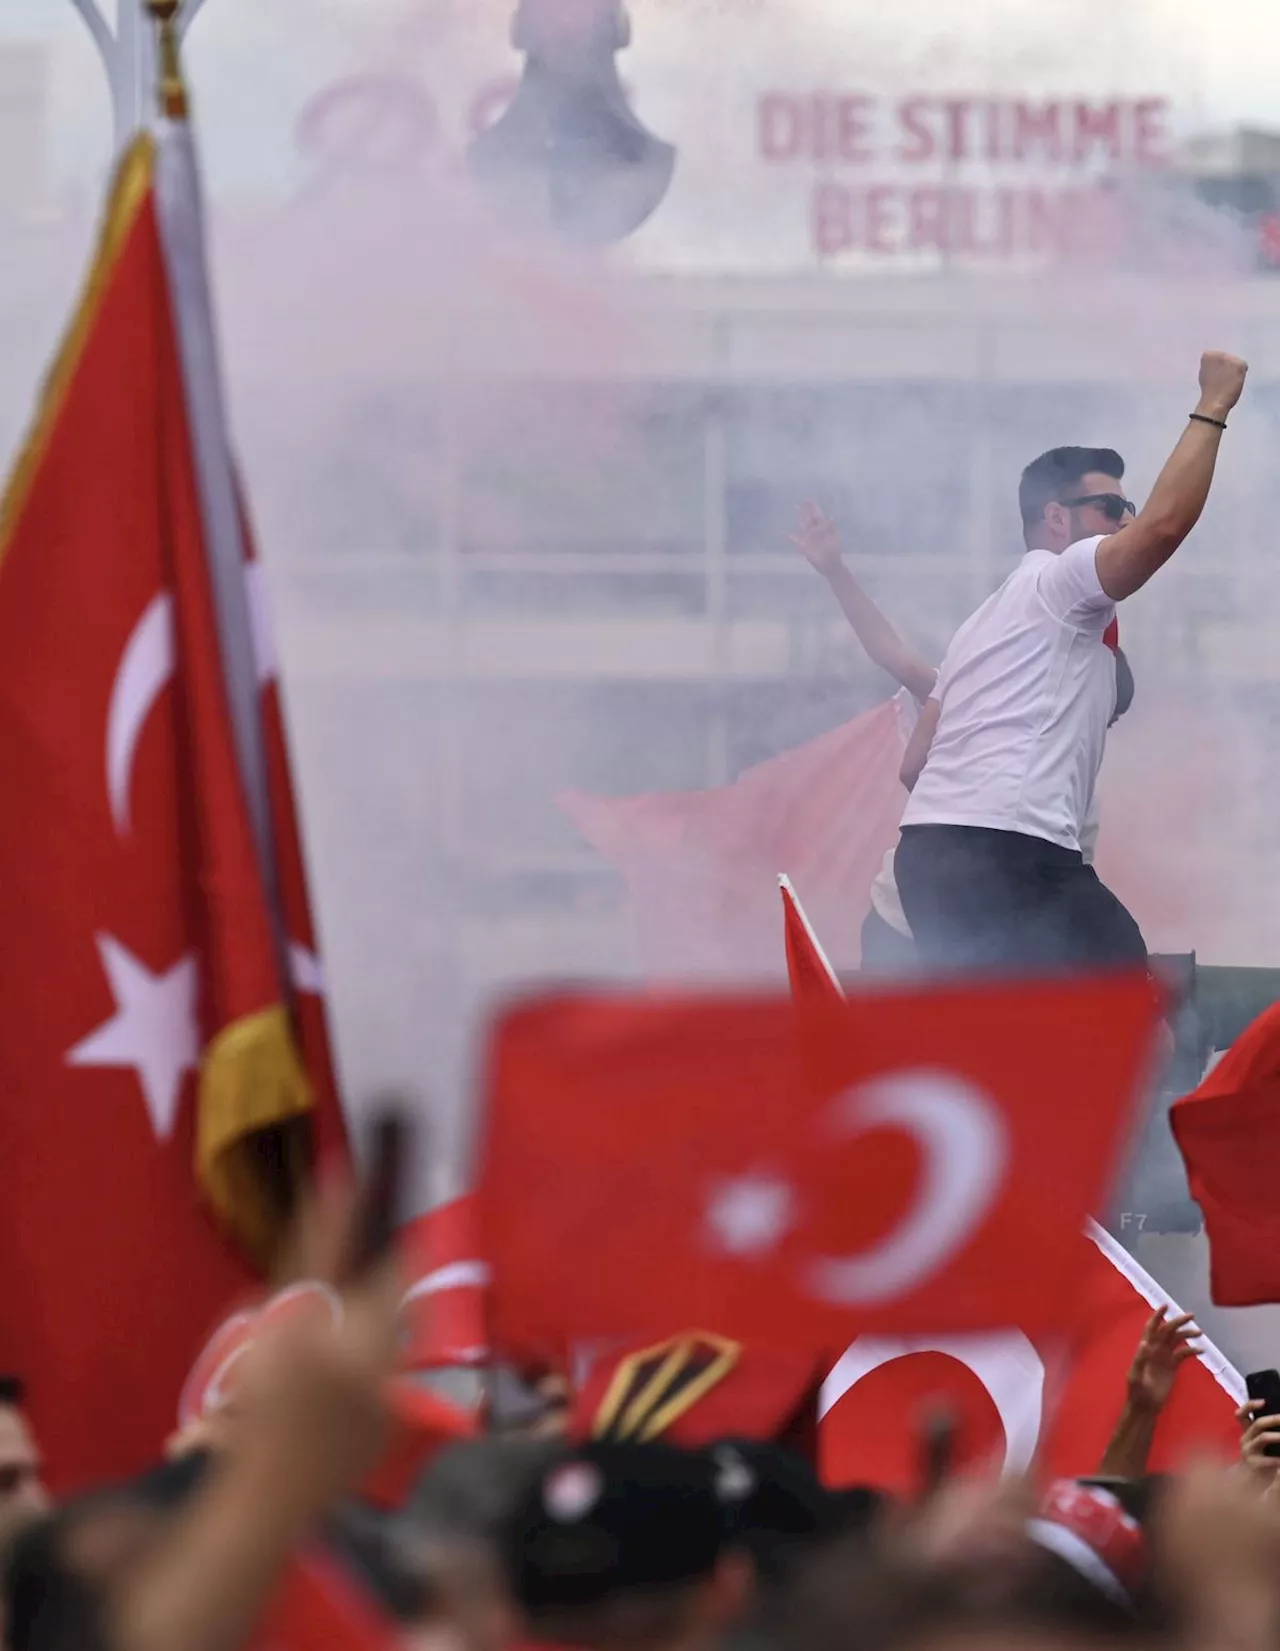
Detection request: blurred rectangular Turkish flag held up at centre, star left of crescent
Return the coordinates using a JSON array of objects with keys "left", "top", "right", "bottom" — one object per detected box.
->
[{"left": 479, "top": 976, "right": 1156, "bottom": 1351}]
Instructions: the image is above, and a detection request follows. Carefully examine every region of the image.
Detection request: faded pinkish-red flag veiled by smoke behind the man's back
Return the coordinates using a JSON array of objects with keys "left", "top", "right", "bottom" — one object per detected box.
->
[{"left": 560, "top": 700, "right": 907, "bottom": 981}]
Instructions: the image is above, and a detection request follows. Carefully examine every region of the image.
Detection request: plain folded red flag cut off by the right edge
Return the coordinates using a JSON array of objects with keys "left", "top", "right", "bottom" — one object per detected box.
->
[{"left": 1169, "top": 1004, "right": 1280, "bottom": 1308}]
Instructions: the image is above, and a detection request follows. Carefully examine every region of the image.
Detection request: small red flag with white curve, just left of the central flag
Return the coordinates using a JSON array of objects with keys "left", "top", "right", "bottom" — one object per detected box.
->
[{"left": 401, "top": 1197, "right": 489, "bottom": 1370}]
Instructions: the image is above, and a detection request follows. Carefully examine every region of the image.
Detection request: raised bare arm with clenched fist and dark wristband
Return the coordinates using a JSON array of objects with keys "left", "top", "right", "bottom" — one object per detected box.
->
[{"left": 1097, "top": 350, "right": 1249, "bottom": 603}]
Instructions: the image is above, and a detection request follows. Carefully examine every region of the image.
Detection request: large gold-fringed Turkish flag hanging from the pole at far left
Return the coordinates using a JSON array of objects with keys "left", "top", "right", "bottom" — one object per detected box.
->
[{"left": 0, "top": 138, "right": 345, "bottom": 1491}]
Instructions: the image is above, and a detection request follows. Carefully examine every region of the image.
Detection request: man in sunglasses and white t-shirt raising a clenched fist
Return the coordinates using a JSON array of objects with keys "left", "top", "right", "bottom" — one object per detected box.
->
[{"left": 895, "top": 352, "right": 1247, "bottom": 972}]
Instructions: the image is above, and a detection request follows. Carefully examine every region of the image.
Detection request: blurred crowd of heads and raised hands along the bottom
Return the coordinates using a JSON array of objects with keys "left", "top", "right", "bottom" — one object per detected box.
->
[{"left": 0, "top": 1190, "right": 1280, "bottom": 1651}]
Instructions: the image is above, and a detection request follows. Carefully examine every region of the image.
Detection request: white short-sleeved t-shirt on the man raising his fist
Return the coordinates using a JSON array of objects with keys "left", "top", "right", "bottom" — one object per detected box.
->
[{"left": 902, "top": 537, "right": 1115, "bottom": 849}]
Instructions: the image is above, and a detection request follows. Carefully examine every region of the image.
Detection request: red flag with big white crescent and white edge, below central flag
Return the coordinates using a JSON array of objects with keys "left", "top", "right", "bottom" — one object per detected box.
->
[{"left": 819, "top": 1222, "right": 1244, "bottom": 1493}]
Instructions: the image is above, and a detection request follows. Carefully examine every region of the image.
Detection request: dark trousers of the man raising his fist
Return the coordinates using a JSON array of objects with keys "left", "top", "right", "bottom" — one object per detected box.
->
[{"left": 894, "top": 826, "right": 1146, "bottom": 972}]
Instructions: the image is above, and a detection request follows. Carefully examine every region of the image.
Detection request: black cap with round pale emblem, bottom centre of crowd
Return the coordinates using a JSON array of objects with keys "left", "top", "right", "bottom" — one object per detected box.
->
[{"left": 502, "top": 1443, "right": 727, "bottom": 1616}]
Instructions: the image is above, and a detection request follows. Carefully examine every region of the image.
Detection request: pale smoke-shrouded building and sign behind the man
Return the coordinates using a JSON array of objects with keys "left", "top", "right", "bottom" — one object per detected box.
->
[{"left": 0, "top": 0, "right": 1280, "bottom": 1353}]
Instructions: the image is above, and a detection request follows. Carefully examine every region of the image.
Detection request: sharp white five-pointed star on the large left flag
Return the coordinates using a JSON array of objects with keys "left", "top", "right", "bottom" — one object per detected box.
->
[{"left": 66, "top": 934, "right": 200, "bottom": 1141}]
